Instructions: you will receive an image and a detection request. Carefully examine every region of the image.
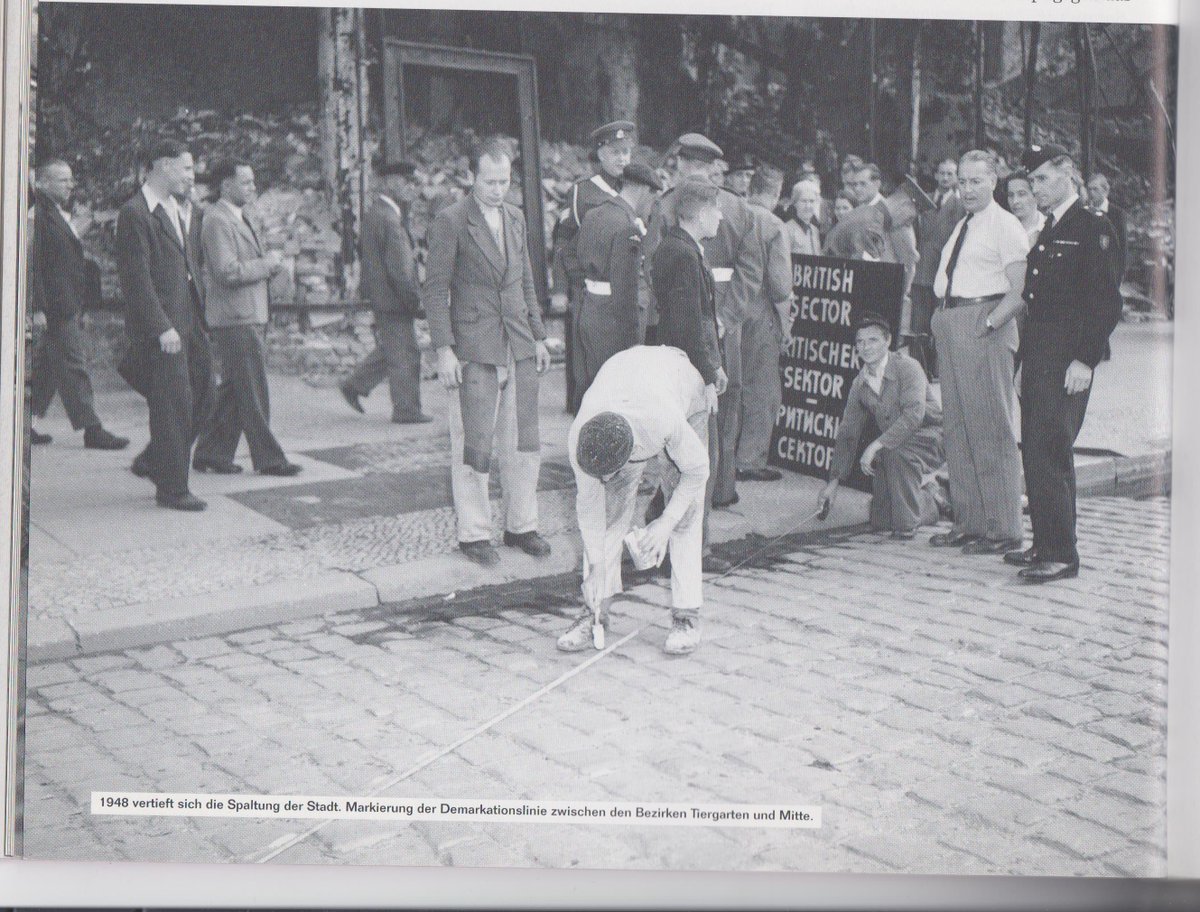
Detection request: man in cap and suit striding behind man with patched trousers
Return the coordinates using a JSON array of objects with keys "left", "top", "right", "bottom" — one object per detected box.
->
[{"left": 342, "top": 162, "right": 433, "bottom": 425}]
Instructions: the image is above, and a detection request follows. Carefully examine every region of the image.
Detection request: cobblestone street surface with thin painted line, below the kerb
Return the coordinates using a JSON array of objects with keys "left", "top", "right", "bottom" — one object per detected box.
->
[{"left": 25, "top": 497, "right": 1170, "bottom": 876}]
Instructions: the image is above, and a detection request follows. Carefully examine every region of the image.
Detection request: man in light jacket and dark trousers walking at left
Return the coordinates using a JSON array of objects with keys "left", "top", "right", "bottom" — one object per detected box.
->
[{"left": 192, "top": 158, "right": 300, "bottom": 476}]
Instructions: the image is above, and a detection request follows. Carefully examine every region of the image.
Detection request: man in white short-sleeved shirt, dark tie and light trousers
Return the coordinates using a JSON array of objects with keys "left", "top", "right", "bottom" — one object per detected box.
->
[{"left": 930, "top": 151, "right": 1028, "bottom": 554}]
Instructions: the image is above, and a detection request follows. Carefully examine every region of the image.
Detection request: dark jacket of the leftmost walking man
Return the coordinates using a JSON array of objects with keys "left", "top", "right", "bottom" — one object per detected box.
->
[{"left": 30, "top": 193, "right": 96, "bottom": 323}]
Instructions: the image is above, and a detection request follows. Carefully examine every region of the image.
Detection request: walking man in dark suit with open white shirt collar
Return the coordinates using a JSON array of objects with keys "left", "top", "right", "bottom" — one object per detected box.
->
[{"left": 116, "top": 139, "right": 212, "bottom": 511}]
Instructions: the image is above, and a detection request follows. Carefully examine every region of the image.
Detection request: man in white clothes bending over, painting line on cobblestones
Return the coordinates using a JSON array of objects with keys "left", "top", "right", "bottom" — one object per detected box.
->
[{"left": 558, "top": 346, "right": 716, "bottom": 655}]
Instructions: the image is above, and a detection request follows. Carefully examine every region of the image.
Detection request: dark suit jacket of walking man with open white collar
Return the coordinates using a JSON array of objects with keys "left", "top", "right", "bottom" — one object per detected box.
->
[{"left": 116, "top": 190, "right": 204, "bottom": 346}]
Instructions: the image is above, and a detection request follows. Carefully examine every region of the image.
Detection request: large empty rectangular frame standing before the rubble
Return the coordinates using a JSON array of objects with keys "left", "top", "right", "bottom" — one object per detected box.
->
[{"left": 383, "top": 38, "right": 550, "bottom": 307}]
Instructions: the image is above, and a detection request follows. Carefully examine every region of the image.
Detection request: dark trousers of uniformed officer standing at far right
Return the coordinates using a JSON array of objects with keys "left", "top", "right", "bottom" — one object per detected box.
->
[{"left": 1021, "top": 324, "right": 1091, "bottom": 564}]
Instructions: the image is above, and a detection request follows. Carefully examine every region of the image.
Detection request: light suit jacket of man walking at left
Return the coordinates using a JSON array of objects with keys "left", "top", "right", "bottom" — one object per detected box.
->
[{"left": 200, "top": 203, "right": 271, "bottom": 326}]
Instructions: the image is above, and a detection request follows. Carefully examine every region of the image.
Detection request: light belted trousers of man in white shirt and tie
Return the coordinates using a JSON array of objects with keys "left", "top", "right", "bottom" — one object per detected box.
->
[{"left": 932, "top": 304, "right": 1024, "bottom": 541}]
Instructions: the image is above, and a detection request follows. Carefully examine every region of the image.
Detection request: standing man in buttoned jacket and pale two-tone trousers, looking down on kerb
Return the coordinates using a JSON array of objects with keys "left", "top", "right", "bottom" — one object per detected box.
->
[{"left": 421, "top": 142, "right": 550, "bottom": 566}]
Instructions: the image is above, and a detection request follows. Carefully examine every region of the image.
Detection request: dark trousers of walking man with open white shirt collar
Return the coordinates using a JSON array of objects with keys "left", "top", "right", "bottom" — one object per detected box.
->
[{"left": 134, "top": 325, "right": 214, "bottom": 497}]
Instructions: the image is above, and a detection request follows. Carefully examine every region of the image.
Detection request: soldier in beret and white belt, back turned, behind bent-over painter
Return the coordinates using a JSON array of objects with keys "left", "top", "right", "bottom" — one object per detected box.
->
[{"left": 575, "top": 163, "right": 662, "bottom": 401}]
